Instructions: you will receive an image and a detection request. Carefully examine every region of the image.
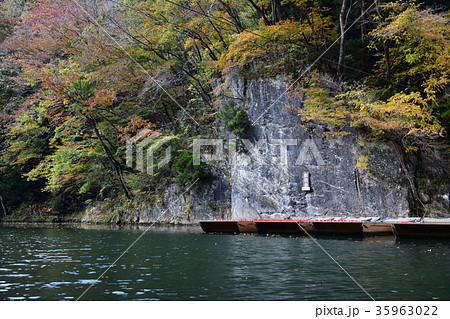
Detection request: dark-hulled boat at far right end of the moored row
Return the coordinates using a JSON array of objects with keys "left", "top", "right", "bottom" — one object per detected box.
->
[{"left": 393, "top": 222, "right": 450, "bottom": 238}]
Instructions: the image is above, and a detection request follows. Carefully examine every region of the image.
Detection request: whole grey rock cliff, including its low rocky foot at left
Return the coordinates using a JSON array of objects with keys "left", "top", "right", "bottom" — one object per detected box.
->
[{"left": 83, "top": 76, "right": 449, "bottom": 223}]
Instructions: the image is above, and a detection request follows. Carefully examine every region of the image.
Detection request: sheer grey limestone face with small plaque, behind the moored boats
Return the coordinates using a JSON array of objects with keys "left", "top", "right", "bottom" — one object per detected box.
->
[{"left": 227, "top": 77, "right": 410, "bottom": 218}]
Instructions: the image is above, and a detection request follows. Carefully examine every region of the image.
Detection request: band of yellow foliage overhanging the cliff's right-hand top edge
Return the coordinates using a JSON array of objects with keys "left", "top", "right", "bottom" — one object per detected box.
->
[{"left": 297, "top": 75, "right": 444, "bottom": 136}]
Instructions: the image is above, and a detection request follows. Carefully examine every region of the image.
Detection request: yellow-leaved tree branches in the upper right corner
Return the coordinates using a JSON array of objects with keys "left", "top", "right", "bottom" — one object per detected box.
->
[{"left": 371, "top": 1, "right": 450, "bottom": 101}]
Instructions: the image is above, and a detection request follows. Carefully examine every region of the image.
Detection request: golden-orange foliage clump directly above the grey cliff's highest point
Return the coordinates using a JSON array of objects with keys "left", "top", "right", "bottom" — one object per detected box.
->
[{"left": 216, "top": 0, "right": 337, "bottom": 75}]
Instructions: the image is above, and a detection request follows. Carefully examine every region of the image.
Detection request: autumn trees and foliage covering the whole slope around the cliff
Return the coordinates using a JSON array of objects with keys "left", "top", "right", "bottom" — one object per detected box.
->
[{"left": 0, "top": 0, "right": 450, "bottom": 221}]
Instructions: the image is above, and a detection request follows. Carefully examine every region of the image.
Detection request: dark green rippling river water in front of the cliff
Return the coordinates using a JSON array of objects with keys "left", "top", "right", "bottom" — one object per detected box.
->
[{"left": 0, "top": 226, "right": 450, "bottom": 300}]
